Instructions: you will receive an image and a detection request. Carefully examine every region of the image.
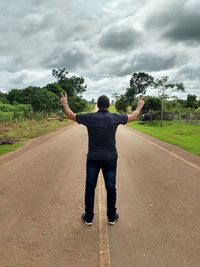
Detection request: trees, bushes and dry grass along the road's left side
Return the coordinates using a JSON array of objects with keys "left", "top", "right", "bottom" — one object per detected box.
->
[{"left": 0, "top": 68, "right": 94, "bottom": 155}]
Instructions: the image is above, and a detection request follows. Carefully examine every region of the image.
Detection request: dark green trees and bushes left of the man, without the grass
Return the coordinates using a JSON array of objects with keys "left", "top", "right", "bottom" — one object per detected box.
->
[{"left": 0, "top": 68, "right": 89, "bottom": 124}]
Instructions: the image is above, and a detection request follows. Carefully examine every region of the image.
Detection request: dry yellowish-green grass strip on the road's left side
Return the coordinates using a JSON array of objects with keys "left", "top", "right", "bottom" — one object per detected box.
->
[{"left": 0, "top": 119, "right": 69, "bottom": 155}]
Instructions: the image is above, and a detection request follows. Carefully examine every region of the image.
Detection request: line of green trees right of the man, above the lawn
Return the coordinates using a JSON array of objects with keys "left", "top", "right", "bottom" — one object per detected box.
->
[{"left": 113, "top": 72, "right": 200, "bottom": 126}]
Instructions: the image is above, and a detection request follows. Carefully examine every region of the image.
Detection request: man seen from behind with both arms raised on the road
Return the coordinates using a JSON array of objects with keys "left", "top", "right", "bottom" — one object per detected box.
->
[{"left": 61, "top": 93, "right": 144, "bottom": 225}]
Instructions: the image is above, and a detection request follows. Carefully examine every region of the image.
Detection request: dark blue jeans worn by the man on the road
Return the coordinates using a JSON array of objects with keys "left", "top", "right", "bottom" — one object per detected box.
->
[{"left": 85, "top": 159, "right": 117, "bottom": 220}]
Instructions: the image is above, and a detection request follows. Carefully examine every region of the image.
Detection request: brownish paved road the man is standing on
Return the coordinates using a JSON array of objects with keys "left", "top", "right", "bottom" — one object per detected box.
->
[{"left": 0, "top": 124, "right": 200, "bottom": 267}]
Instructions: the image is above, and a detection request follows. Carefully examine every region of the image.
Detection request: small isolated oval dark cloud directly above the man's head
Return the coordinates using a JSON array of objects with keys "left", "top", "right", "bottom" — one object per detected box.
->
[{"left": 99, "top": 27, "right": 141, "bottom": 50}]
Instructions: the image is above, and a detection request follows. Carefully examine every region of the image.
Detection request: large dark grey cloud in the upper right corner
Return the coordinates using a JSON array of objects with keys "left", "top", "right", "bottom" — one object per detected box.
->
[{"left": 145, "top": 0, "right": 200, "bottom": 43}]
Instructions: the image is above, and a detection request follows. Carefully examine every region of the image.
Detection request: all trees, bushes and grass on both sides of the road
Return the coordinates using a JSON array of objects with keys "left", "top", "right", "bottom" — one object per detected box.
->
[{"left": 0, "top": 68, "right": 200, "bottom": 155}]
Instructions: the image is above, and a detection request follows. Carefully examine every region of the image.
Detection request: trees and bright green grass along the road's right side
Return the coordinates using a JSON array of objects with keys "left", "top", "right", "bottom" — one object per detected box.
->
[{"left": 110, "top": 72, "right": 200, "bottom": 155}]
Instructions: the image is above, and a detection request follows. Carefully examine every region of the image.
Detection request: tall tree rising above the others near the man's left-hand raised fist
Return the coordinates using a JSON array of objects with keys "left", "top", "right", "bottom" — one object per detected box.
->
[{"left": 52, "top": 68, "right": 87, "bottom": 97}]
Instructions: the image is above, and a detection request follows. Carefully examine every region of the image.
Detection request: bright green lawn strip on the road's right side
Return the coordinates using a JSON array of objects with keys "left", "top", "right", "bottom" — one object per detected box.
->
[{"left": 128, "top": 121, "right": 200, "bottom": 155}]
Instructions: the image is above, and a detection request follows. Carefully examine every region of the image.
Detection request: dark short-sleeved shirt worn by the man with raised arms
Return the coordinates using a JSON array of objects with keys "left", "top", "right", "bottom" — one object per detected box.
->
[{"left": 76, "top": 110, "right": 128, "bottom": 160}]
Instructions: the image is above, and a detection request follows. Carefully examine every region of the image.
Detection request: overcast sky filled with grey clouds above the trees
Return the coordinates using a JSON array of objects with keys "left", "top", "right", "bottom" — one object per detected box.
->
[{"left": 0, "top": 0, "right": 200, "bottom": 100}]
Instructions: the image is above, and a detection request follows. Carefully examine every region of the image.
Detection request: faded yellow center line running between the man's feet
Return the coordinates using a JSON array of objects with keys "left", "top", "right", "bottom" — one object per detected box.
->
[{"left": 98, "top": 173, "right": 111, "bottom": 267}]
